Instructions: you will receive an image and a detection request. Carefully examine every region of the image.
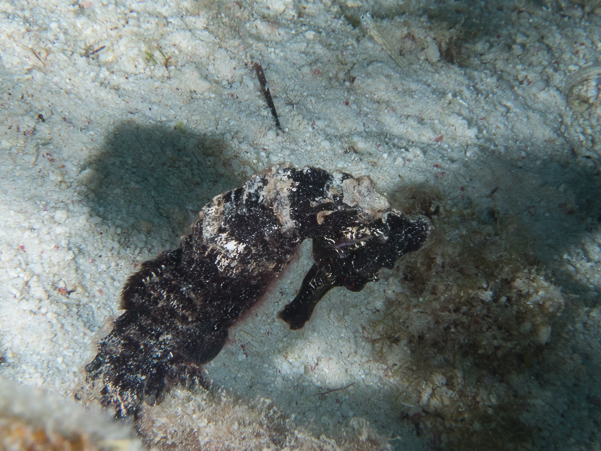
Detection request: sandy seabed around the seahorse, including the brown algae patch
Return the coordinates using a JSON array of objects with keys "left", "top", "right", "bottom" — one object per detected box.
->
[{"left": 0, "top": 0, "right": 601, "bottom": 450}]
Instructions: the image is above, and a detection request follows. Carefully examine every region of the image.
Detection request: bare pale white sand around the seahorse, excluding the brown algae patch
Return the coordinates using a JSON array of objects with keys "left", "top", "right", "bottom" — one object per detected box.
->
[{"left": 0, "top": 0, "right": 601, "bottom": 449}]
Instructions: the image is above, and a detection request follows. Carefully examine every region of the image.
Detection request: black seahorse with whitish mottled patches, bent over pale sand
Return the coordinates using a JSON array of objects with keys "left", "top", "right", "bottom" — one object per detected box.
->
[{"left": 86, "top": 166, "right": 428, "bottom": 417}]
